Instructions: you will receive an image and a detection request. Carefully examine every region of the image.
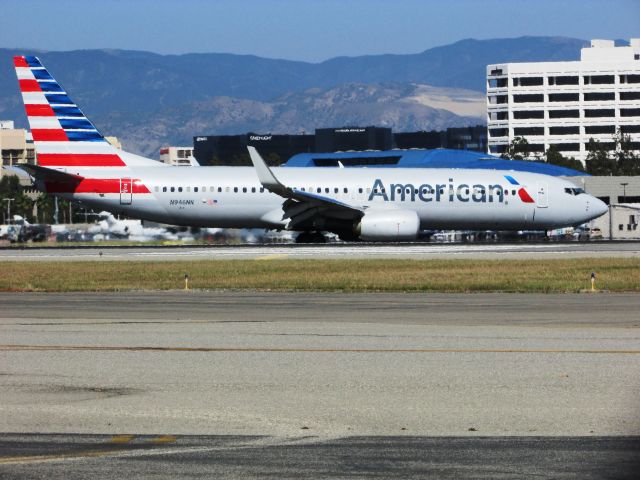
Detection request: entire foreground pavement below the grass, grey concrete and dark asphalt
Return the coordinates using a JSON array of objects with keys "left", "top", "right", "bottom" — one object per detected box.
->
[{"left": 0, "top": 291, "right": 640, "bottom": 478}]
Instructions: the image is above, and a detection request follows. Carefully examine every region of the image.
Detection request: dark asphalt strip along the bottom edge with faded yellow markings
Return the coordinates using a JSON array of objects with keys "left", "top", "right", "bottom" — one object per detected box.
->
[{"left": 0, "top": 435, "right": 640, "bottom": 480}]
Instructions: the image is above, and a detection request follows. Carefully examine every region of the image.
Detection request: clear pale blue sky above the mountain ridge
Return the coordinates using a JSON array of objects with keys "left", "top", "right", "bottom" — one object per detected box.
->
[{"left": 0, "top": 0, "right": 640, "bottom": 62}]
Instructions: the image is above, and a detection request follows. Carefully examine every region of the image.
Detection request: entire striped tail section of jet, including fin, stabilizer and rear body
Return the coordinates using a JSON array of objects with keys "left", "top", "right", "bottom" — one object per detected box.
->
[{"left": 13, "top": 56, "right": 166, "bottom": 199}]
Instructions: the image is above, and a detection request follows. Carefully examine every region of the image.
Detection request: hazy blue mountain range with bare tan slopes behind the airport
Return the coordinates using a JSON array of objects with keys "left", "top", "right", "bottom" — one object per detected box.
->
[{"left": 0, "top": 37, "right": 587, "bottom": 157}]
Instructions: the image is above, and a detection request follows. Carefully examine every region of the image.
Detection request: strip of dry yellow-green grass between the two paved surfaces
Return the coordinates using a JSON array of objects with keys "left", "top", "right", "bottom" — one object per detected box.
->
[{"left": 0, "top": 258, "right": 640, "bottom": 293}]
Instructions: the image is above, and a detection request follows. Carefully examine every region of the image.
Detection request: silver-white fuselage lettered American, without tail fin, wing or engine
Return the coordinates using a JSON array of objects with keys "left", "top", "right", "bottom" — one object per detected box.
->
[{"left": 40, "top": 166, "right": 606, "bottom": 230}]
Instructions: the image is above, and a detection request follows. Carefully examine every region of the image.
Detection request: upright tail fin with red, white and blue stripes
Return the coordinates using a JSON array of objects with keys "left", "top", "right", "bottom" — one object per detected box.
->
[{"left": 13, "top": 55, "right": 163, "bottom": 168}]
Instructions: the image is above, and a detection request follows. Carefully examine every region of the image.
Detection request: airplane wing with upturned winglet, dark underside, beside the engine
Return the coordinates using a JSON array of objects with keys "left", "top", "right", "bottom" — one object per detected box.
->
[{"left": 248, "top": 146, "right": 365, "bottom": 229}]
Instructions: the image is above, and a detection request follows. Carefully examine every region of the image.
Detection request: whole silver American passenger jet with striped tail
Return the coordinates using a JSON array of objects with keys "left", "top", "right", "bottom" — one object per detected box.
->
[{"left": 14, "top": 56, "right": 607, "bottom": 243}]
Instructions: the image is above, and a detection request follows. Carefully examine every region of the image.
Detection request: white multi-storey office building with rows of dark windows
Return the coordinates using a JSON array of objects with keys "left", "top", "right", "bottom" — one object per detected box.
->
[{"left": 487, "top": 38, "right": 640, "bottom": 163}]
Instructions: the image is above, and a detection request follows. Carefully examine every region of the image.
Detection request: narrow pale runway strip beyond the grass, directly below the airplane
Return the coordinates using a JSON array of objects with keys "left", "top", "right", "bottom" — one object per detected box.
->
[{"left": 0, "top": 242, "right": 640, "bottom": 262}]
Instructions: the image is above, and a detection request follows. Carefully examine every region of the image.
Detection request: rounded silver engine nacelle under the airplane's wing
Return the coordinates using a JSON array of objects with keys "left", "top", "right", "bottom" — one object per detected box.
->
[{"left": 356, "top": 209, "right": 420, "bottom": 242}]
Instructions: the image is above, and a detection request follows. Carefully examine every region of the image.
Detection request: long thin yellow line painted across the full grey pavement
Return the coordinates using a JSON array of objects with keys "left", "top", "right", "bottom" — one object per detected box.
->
[{"left": 0, "top": 345, "right": 640, "bottom": 355}]
